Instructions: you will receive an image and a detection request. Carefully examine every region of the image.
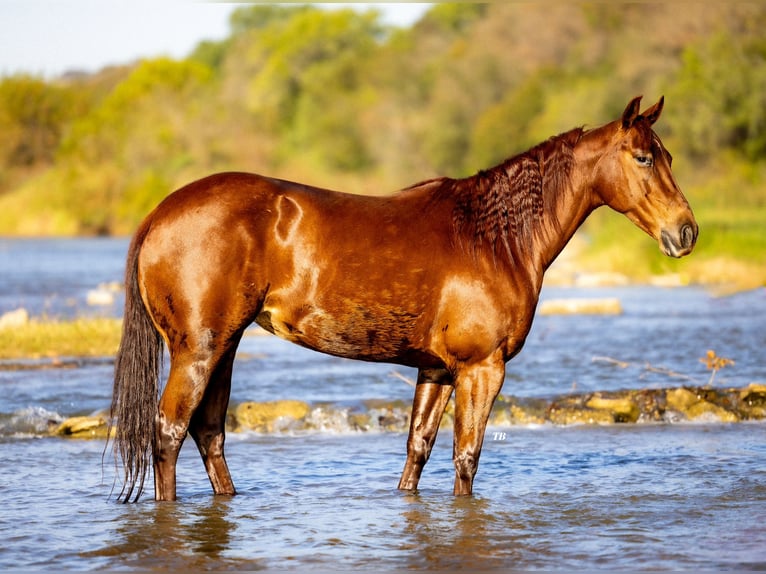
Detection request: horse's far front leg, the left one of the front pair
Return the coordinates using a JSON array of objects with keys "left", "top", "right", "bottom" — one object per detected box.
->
[{"left": 399, "top": 369, "right": 453, "bottom": 490}]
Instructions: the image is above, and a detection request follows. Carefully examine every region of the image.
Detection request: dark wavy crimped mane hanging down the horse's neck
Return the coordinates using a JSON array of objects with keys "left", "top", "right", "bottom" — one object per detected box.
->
[{"left": 445, "top": 128, "right": 584, "bottom": 262}]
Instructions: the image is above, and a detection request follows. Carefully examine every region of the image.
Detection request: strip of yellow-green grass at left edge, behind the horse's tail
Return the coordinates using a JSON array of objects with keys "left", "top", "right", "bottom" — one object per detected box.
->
[{"left": 0, "top": 318, "right": 122, "bottom": 360}]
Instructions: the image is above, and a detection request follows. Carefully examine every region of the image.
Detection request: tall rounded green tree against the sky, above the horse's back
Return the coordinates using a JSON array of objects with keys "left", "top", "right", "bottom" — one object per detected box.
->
[{"left": 248, "top": 9, "right": 382, "bottom": 169}]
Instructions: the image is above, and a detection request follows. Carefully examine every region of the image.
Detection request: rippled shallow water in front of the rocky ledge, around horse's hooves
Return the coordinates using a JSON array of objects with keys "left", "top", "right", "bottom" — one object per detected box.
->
[{"left": 0, "top": 424, "right": 766, "bottom": 570}]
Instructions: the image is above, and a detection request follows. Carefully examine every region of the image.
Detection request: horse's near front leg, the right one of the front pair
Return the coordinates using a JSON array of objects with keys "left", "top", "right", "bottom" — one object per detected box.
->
[{"left": 452, "top": 351, "right": 505, "bottom": 495}]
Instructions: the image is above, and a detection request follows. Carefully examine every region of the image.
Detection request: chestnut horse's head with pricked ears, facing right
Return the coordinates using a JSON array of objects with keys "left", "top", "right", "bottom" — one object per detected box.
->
[{"left": 594, "top": 96, "right": 699, "bottom": 257}]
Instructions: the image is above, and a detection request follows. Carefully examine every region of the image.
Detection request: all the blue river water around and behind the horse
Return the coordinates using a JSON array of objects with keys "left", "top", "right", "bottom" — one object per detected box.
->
[{"left": 0, "top": 239, "right": 766, "bottom": 571}]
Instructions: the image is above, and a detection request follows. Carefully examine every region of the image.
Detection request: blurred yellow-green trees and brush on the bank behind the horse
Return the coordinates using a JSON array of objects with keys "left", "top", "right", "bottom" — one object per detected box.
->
[{"left": 0, "top": 2, "right": 766, "bottom": 286}]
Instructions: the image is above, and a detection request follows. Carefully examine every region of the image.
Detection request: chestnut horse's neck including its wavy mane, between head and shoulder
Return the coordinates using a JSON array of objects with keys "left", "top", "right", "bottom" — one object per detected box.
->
[{"left": 448, "top": 130, "right": 600, "bottom": 287}]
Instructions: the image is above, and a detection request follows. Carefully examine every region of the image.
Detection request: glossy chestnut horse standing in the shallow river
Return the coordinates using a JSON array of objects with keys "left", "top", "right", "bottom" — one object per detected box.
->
[{"left": 110, "top": 96, "right": 698, "bottom": 502}]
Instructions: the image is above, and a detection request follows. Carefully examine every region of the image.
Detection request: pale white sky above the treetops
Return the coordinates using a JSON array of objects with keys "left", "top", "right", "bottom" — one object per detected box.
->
[{"left": 0, "top": 0, "right": 429, "bottom": 78}]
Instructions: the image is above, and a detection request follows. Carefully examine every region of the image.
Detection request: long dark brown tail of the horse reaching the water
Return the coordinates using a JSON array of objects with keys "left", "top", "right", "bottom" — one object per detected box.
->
[{"left": 109, "top": 224, "right": 163, "bottom": 502}]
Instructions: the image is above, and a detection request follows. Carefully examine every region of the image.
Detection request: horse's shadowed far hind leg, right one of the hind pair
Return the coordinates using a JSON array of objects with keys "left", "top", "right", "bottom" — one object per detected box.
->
[{"left": 189, "top": 345, "right": 237, "bottom": 495}]
